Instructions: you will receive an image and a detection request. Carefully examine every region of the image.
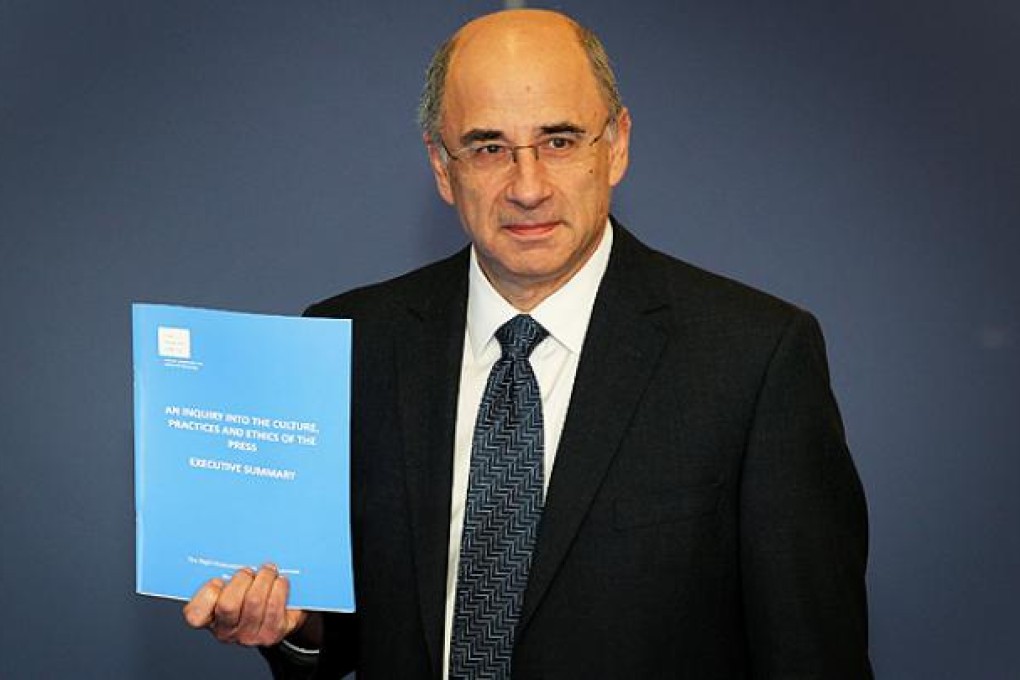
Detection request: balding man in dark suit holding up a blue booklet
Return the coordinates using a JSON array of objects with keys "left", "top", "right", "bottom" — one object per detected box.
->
[{"left": 185, "top": 10, "right": 871, "bottom": 680}]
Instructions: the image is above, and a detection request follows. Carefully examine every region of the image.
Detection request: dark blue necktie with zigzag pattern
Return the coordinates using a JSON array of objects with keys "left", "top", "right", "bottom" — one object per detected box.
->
[{"left": 450, "top": 314, "right": 549, "bottom": 680}]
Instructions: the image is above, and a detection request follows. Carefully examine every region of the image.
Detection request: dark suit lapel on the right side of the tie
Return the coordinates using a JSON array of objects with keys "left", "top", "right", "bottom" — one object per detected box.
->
[{"left": 520, "top": 224, "right": 667, "bottom": 626}]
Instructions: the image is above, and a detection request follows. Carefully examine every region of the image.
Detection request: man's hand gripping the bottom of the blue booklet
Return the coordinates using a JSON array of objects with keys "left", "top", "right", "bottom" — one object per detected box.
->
[{"left": 184, "top": 565, "right": 308, "bottom": 646}]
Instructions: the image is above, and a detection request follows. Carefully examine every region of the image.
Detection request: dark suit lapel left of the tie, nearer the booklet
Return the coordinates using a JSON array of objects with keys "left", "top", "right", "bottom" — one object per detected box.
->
[{"left": 397, "top": 251, "right": 467, "bottom": 677}]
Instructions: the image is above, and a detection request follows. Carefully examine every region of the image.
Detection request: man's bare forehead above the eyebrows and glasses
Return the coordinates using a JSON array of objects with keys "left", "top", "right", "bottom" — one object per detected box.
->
[{"left": 443, "top": 16, "right": 605, "bottom": 132}]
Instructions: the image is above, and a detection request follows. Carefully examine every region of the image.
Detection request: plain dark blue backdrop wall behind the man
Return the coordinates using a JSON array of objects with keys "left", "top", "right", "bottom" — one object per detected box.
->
[{"left": 0, "top": 0, "right": 1020, "bottom": 680}]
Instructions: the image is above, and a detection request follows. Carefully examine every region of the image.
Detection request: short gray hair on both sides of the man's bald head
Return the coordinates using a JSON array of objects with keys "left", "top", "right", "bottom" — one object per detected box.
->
[{"left": 418, "top": 17, "right": 623, "bottom": 143}]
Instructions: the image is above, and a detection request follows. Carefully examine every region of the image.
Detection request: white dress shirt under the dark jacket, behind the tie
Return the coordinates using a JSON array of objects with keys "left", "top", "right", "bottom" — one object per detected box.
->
[{"left": 443, "top": 221, "right": 613, "bottom": 678}]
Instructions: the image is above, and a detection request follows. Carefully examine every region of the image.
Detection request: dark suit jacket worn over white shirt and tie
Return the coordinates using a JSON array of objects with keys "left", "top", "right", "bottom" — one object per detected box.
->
[{"left": 270, "top": 225, "right": 871, "bottom": 680}]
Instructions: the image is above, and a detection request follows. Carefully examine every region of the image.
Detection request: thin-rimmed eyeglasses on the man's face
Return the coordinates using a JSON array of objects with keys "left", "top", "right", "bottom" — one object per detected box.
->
[{"left": 440, "top": 117, "right": 613, "bottom": 172}]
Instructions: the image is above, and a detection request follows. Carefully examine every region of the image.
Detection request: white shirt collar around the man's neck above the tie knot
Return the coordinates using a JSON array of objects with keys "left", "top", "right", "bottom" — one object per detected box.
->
[{"left": 467, "top": 220, "right": 613, "bottom": 358}]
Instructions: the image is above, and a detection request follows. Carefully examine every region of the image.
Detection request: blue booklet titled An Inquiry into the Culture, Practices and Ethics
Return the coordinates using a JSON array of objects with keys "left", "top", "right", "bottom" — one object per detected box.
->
[{"left": 132, "top": 305, "right": 354, "bottom": 612}]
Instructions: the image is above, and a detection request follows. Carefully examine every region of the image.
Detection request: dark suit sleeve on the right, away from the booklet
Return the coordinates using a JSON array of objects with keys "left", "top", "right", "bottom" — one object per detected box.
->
[{"left": 740, "top": 312, "right": 872, "bottom": 680}]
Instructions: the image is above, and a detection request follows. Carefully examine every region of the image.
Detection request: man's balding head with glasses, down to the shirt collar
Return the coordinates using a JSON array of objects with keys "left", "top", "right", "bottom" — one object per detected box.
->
[{"left": 416, "top": 10, "right": 630, "bottom": 311}]
